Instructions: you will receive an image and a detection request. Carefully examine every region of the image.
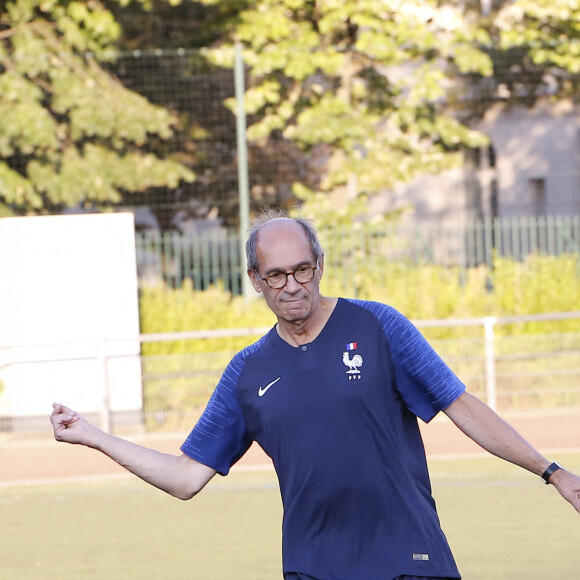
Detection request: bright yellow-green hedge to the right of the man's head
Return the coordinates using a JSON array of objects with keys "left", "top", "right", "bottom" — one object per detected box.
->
[{"left": 342, "top": 254, "right": 580, "bottom": 338}]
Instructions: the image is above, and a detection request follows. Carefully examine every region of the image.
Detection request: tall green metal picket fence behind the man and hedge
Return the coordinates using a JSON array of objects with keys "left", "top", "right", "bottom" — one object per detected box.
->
[{"left": 136, "top": 215, "right": 580, "bottom": 294}]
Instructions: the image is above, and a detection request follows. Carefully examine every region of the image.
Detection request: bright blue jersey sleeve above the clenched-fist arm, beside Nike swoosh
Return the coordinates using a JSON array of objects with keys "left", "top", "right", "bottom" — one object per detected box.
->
[{"left": 181, "top": 353, "right": 251, "bottom": 475}]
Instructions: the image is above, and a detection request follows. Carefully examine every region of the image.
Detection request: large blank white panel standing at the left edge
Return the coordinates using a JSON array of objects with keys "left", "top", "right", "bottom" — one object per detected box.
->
[{"left": 0, "top": 213, "right": 142, "bottom": 417}]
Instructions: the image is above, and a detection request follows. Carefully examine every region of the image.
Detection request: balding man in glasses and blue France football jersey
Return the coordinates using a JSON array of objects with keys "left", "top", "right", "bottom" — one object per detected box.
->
[{"left": 51, "top": 212, "right": 580, "bottom": 580}]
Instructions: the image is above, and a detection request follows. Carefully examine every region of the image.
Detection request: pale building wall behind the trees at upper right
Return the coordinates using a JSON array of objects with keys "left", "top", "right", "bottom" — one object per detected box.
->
[{"left": 370, "top": 101, "right": 580, "bottom": 224}]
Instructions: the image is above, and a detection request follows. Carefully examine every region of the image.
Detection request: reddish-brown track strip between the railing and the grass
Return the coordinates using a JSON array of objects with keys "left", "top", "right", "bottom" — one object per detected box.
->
[{"left": 0, "top": 409, "right": 580, "bottom": 485}]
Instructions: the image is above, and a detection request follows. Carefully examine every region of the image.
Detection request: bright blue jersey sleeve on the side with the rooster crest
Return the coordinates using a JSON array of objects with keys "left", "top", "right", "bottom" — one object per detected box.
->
[{"left": 358, "top": 303, "right": 465, "bottom": 422}]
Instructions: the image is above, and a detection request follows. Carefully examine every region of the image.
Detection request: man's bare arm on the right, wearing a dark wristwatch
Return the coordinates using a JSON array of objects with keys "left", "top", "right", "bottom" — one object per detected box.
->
[{"left": 445, "top": 392, "right": 580, "bottom": 513}]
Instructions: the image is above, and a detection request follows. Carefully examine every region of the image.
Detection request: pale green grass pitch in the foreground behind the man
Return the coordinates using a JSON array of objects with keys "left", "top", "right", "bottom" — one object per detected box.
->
[{"left": 0, "top": 454, "right": 580, "bottom": 580}]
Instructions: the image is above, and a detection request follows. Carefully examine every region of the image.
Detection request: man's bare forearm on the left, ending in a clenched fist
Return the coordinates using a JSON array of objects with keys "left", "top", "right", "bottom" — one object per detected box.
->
[{"left": 50, "top": 403, "right": 216, "bottom": 499}]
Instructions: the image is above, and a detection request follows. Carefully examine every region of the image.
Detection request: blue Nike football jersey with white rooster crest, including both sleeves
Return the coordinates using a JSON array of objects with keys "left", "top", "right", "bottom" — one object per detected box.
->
[{"left": 182, "top": 299, "right": 465, "bottom": 580}]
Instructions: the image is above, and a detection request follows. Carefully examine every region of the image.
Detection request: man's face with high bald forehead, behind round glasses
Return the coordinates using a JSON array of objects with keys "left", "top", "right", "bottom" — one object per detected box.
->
[{"left": 248, "top": 219, "right": 324, "bottom": 322}]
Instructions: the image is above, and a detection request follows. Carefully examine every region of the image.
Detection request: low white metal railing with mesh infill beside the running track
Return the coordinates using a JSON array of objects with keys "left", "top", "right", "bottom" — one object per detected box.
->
[{"left": 0, "top": 312, "right": 580, "bottom": 438}]
